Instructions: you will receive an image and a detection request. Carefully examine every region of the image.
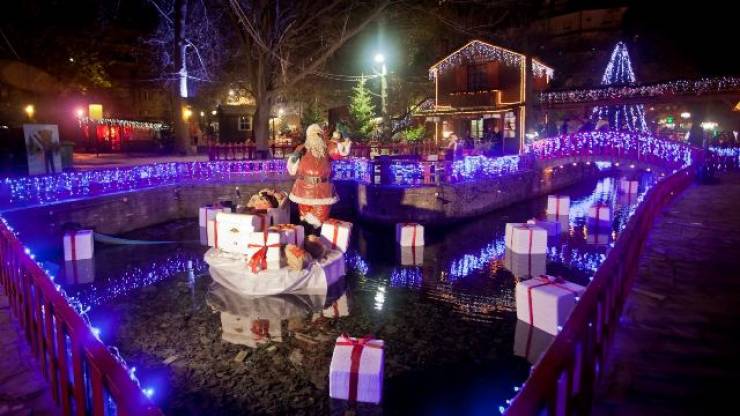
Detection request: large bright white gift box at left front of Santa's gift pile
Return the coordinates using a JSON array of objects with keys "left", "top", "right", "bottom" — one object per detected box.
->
[{"left": 208, "top": 212, "right": 267, "bottom": 254}]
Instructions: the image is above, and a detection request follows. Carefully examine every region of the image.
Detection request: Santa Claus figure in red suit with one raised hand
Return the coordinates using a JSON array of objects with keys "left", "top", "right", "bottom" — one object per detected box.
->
[{"left": 288, "top": 124, "right": 351, "bottom": 228}]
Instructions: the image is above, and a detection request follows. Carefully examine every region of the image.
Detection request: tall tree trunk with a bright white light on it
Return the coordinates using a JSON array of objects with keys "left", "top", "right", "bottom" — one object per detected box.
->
[{"left": 172, "top": 0, "right": 194, "bottom": 155}]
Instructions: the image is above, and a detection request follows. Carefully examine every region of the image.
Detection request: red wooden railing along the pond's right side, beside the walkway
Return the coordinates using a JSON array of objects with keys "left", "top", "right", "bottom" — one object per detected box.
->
[{"left": 505, "top": 166, "right": 695, "bottom": 416}]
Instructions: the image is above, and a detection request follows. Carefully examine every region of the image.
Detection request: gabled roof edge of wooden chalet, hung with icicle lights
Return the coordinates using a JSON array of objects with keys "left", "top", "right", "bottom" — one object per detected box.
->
[{"left": 429, "top": 39, "right": 555, "bottom": 79}]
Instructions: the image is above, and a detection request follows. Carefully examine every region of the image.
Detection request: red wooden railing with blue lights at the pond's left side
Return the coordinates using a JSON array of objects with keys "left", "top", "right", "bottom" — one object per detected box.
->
[{"left": 0, "top": 222, "right": 162, "bottom": 416}]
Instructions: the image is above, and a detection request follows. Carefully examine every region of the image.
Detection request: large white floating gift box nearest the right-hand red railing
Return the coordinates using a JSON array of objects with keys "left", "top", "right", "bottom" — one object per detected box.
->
[{"left": 515, "top": 276, "right": 585, "bottom": 335}]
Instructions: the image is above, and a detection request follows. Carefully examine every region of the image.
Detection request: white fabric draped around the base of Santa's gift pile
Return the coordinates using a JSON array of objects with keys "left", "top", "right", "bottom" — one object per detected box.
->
[{"left": 205, "top": 248, "right": 345, "bottom": 296}]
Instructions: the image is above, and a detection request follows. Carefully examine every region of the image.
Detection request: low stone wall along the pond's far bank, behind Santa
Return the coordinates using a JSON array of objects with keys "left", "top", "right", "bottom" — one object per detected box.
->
[{"left": 3, "top": 164, "right": 598, "bottom": 235}]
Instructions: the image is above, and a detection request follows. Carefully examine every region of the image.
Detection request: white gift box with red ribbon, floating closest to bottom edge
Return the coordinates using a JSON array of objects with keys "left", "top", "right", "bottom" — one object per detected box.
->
[{"left": 329, "top": 336, "right": 384, "bottom": 404}]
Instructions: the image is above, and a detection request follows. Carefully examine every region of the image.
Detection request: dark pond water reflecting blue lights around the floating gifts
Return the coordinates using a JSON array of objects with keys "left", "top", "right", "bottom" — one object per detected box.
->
[{"left": 13, "top": 172, "right": 654, "bottom": 415}]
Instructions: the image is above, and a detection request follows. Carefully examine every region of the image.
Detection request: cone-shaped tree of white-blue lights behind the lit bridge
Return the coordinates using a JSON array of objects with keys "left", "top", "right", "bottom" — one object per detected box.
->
[{"left": 592, "top": 42, "right": 648, "bottom": 131}]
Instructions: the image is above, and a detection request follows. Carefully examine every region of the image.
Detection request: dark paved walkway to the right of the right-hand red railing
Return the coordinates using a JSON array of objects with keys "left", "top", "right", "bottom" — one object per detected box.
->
[{"left": 593, "top": 173, "right": 740, "bottom": 415}]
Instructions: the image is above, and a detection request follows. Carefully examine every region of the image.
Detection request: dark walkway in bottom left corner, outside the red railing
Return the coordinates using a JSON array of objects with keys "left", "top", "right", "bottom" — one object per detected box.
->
[{"left": 0, "top": 294, "right": 57, "bottom": 416}]
